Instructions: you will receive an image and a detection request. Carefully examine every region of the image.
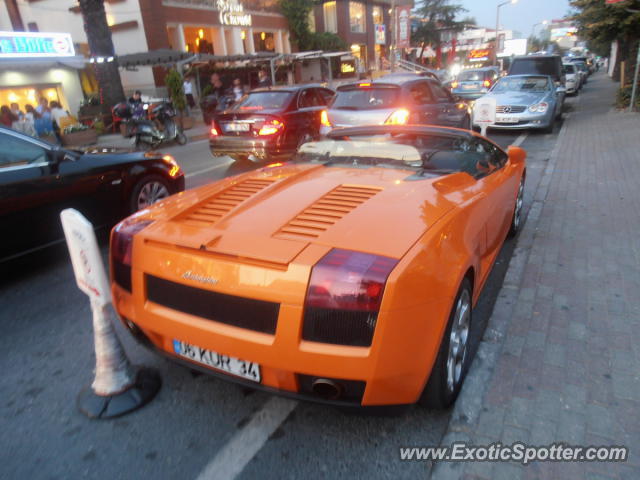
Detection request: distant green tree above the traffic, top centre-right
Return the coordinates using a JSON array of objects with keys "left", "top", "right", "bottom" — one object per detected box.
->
[{"left": 411, "top": 0, "right": 468, "bottom": 62}]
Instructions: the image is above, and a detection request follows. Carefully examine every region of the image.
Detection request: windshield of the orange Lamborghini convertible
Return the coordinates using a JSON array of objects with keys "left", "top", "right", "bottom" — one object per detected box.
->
[{"left": 293, "top": 133, "right": 498, "bottom": 175}]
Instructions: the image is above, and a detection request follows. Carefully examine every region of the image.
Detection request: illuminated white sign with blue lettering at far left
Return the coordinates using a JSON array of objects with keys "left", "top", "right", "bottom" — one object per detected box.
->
[{"left": 0, "top": 32, "right": 75, "bottom": 58}]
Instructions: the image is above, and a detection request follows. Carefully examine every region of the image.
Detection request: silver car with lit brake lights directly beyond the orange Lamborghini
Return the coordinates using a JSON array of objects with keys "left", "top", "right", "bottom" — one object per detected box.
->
[{"left": 321, "top": 73, "right": 471, "bottom": 135}]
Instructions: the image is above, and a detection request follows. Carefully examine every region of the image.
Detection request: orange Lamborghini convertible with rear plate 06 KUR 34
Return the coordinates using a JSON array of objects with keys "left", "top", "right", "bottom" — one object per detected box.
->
[{"left": 110, "top": 125, "right": 526, "bottom": 408}]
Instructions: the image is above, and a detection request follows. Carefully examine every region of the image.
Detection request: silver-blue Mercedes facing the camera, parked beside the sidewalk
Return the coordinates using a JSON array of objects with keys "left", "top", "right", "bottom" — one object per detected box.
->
[{"left": 474, "top": 75, "right": 561, "bottom": 133}]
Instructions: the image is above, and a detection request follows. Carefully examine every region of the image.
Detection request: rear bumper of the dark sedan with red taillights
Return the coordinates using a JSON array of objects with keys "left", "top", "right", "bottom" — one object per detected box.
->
[{"left": 209, "top": 136, "right": 295, "bottom": 161}]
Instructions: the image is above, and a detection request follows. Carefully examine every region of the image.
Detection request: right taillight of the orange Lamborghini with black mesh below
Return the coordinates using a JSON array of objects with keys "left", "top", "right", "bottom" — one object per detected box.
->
[{"left": 302, "top": 249, "right": 398, "bottom": 346}]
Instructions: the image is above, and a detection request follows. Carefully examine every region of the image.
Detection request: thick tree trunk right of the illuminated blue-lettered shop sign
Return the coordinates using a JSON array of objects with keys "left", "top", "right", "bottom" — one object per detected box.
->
[{"left": 79, "top": 0, "right": 125, "bottom": 115}]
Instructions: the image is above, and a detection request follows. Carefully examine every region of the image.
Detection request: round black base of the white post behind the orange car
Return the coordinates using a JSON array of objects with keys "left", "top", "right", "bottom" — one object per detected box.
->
[{"left": 78, "top": 367, "right": 162, "bottom": 419}]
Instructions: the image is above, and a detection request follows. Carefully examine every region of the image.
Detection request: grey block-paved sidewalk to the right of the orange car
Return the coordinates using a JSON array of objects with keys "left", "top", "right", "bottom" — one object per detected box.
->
[{"left": 432, "top": 73, "right": 640, "bottom": 480}]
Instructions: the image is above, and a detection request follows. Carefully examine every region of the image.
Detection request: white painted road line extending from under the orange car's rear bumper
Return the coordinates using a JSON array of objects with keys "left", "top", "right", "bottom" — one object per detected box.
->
[{"left": 197, "top": 397, "right": 298, "bottom": 480}]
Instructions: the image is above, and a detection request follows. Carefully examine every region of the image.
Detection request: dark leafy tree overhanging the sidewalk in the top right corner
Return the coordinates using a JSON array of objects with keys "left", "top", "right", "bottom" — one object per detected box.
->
[{"left": 571, "top": 0, "right": 640, "bottom": 77}]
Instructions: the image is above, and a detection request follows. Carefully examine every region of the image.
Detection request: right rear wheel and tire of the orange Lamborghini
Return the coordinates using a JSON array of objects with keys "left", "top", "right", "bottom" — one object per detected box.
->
[{"left": 418, "top": 278, "right": 473, "bottom": 410}]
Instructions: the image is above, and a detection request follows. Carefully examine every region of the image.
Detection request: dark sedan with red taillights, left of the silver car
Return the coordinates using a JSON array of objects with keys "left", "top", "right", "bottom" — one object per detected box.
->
[{"left": 209, "top": 85, "right": 334, "bottom": 161}]
